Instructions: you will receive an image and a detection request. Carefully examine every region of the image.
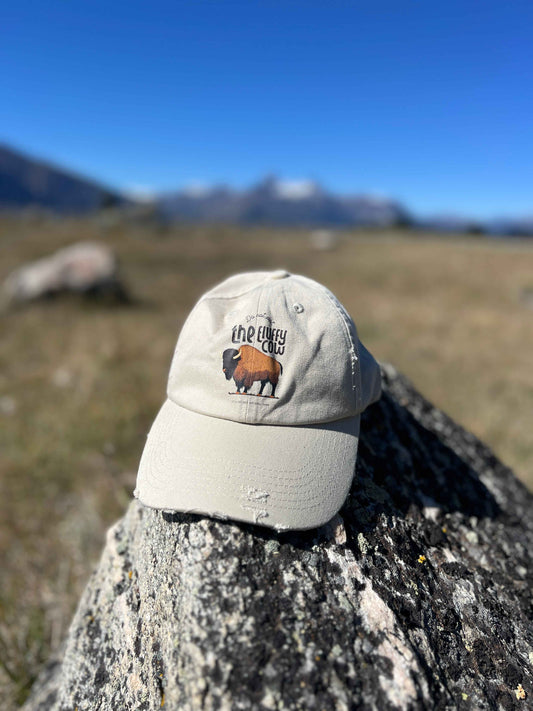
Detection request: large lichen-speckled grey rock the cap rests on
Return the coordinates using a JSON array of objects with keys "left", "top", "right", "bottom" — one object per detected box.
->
[{"left": 24, "top": 366, "right": 533, "bottom": 711}]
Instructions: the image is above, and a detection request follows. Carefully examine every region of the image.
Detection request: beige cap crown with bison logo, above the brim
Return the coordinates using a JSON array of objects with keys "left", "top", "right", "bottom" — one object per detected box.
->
[{"left": 167, "top": 270, "right": 380, "bottom": 426}]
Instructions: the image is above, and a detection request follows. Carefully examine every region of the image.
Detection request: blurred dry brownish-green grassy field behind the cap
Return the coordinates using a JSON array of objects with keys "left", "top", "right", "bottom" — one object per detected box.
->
[{"left": 0, "top": 218, "right": 533, "bottom": 711}]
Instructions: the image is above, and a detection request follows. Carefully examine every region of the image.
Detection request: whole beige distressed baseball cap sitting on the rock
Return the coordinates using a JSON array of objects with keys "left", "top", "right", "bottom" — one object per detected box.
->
[{"left": 134, "top": 270, "right": 381, "bottom": 530}]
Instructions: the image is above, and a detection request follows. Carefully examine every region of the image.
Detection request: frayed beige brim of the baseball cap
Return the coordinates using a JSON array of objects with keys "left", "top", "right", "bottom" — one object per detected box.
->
[{"left": 135, "top": 395, "right": 360, "bottom": 530}]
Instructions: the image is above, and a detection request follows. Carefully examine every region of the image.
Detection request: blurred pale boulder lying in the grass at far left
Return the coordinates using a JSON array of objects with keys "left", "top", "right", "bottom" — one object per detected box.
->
[{"left": 3, "top": 242, "right": 127, "bottom": 304}]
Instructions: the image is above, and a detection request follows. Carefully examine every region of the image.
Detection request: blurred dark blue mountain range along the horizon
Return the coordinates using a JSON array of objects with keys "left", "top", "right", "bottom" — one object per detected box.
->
[{"left": 0, "top": 145, "right": 533, "bottom": 236}]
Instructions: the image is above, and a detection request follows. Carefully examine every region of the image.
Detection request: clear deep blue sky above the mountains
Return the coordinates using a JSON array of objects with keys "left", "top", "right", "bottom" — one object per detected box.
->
[{"left": 0, "top": 0, "right": 533, "bottom": 217}]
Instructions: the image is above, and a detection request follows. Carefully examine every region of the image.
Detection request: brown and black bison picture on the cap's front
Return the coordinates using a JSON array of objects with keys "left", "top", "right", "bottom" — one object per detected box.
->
[{"left": 222, "top": 346, "right": 283, "bottom": 397}]
